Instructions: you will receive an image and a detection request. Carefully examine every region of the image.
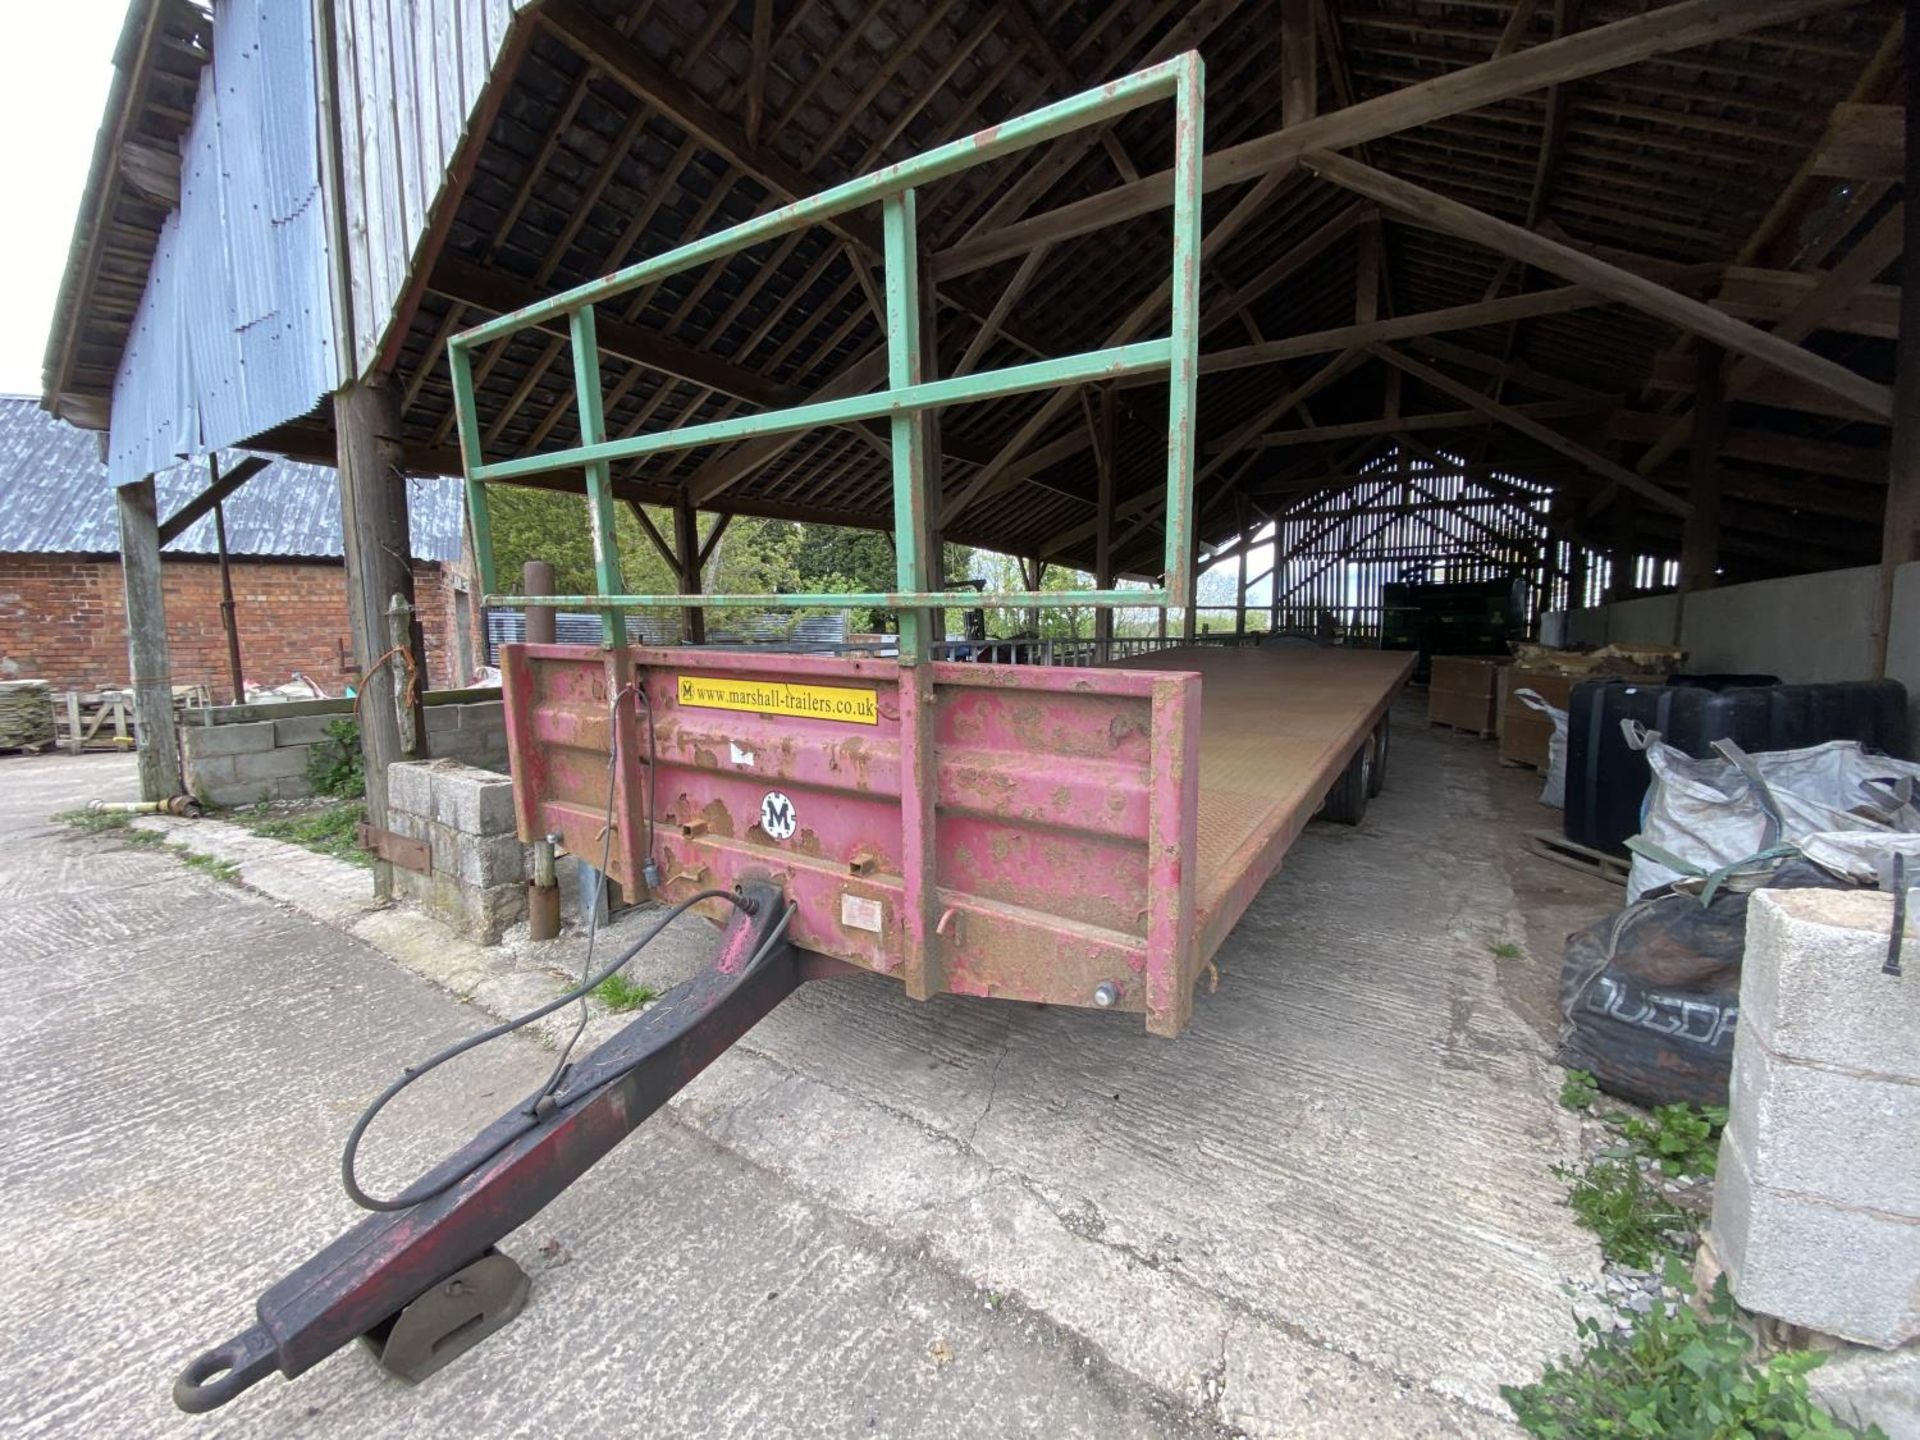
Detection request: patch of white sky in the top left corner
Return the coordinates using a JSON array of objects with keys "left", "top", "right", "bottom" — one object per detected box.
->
[{"left": 0, "top": 0, "right": 127, "bottom": 396}]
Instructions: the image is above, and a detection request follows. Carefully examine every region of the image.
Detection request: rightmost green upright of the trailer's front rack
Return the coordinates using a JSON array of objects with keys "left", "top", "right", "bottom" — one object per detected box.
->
[{"left": 1167, "top": 56, "right": 1206, "bottom": 609}]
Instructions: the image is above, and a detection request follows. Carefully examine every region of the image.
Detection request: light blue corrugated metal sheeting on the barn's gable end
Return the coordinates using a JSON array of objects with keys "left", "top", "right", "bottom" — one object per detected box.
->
[{"left": 108, "top": 0, "right": 340, "bottom": 486}]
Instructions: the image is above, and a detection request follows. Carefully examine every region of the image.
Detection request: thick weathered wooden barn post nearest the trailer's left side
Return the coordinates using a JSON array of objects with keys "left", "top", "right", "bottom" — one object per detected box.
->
[{"left": 334, "top": 380, "right": 426, "bottom": 899}]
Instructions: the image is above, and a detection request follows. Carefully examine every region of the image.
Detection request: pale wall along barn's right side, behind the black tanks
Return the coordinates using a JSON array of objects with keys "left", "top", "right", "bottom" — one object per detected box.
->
[{"left": 1546, "top": 563, "right": 1920, "bottom": 745}]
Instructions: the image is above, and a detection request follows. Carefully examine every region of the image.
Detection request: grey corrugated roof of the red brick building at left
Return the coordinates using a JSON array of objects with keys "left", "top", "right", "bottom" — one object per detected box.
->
[{"left": 0, "top": 407, "right": 461, "bottom": 563}]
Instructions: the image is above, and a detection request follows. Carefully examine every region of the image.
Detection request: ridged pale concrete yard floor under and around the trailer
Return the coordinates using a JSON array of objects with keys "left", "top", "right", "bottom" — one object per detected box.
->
[{"left": 0, "top": 695, "right": 1620, "bottom": 1438}]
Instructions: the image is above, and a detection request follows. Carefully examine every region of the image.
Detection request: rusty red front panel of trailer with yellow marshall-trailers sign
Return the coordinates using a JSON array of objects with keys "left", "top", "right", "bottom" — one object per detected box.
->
[{"left": 503, "top": 645, "right": 1200, "bottom": 1033}]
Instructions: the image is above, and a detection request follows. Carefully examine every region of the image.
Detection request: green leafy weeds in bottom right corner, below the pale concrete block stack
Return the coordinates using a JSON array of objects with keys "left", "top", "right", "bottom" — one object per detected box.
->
[{"left": 1500, "top": 1258, "right": 1885, "bottom": 1440}]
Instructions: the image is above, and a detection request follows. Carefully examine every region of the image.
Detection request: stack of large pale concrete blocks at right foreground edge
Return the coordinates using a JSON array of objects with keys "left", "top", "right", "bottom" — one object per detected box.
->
[{"left": 1713, "top": 889, "right": 1920, "bottom": 1348}]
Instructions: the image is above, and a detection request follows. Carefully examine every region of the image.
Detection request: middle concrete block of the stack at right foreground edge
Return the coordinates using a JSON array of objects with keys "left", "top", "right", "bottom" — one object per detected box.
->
[{"left": 1728, "top": 1033, "right": 1920, "bottom": 1227}]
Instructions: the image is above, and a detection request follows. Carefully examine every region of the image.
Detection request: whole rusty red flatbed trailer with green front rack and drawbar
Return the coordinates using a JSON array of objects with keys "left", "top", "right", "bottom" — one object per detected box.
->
[{"left": 173, "top": 54, "right": 1413, "bottom": 1411}]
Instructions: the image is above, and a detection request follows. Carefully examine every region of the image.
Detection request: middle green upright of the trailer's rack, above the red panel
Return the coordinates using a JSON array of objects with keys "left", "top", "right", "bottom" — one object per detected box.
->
[{"left": 881, "top": 190, "right": 937, "bottom": 664}]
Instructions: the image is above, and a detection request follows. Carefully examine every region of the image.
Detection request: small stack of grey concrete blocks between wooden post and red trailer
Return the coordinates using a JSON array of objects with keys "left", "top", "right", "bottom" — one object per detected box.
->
[{"left": 386, "top": 760, "right": 528, "bottom": 945}]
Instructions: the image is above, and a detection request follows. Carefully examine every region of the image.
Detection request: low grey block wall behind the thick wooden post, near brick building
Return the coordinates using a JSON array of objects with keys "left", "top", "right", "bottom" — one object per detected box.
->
[{"left": 180, "top": 701, "right": 507, "bottom": 806}]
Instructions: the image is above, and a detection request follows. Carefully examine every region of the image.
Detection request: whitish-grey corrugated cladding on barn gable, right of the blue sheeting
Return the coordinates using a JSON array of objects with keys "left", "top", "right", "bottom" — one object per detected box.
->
[{"left": 334, "top": 0, "right": 524, "bottom": 374}]
